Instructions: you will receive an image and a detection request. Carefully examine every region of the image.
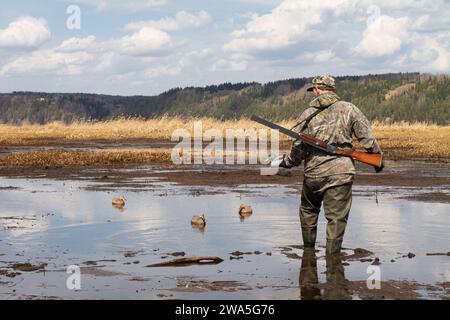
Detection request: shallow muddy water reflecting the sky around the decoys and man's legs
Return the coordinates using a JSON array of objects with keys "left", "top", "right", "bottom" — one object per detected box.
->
[{"left": 0, "top": 168, "right": 450, "bottom": 299}]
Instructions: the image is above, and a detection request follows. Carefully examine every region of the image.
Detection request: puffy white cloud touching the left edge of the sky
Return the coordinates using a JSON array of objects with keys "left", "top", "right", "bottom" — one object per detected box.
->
[{"left": 0, "top": 16, "right": 51, "bottom": 48}]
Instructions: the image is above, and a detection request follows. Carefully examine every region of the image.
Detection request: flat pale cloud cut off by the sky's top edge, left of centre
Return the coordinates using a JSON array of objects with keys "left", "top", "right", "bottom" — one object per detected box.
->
[{"left": 76, "top": 0, "right": 166, "bottom": 13}]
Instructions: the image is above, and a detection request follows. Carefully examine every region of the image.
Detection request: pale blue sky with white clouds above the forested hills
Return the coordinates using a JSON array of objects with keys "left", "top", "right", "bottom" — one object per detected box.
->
[{"left": 0, "top": 0, "right": 450, "bottom": 95}]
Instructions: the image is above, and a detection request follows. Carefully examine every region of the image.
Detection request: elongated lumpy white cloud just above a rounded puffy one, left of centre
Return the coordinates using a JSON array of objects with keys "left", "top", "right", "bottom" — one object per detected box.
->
[{"left": 125, "top": 10, "right": 212, "bottom": 31}]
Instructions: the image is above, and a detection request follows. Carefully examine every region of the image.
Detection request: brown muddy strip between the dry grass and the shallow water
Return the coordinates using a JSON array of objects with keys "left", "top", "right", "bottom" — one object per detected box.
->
[{"left": 0, "top": 163, "right": 450, "bottom": 188}]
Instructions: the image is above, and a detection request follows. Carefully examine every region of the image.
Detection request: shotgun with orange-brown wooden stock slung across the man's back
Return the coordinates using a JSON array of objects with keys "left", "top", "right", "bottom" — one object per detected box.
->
[{"left": 250, "top": 116, "right": 383, "bottom": 168}]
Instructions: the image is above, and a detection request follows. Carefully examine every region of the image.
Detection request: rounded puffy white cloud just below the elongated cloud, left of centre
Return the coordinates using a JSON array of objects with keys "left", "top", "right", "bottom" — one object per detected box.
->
[{"left": 117, "top": 27, "right": 171, "bottom": 56}]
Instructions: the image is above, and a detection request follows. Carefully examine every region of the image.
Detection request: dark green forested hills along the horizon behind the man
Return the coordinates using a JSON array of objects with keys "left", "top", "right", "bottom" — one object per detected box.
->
[{"left": 0, "top": 73, "right": 450, "bottom": 125}]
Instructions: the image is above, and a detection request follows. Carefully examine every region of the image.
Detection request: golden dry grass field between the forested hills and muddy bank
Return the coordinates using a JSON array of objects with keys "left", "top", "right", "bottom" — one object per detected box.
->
[{"left": 0, "top": 118, "right": 450, "bottom": 166}]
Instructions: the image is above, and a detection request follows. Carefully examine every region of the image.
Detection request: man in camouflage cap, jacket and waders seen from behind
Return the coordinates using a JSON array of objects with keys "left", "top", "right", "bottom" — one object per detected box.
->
[{"left": 280, "top": 76, "right": 383, "bottom": 255}]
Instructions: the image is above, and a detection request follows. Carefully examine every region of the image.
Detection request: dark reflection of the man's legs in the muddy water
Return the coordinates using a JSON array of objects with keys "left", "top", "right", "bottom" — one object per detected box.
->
[{"left": 299, "top": 248, "right": 352, "bottom": 300}]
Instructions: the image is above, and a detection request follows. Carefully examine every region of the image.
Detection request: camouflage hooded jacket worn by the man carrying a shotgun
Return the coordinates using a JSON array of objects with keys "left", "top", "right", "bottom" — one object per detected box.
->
[{"left": 284, "top": 92, "right": 381, "bottom": 178}]
